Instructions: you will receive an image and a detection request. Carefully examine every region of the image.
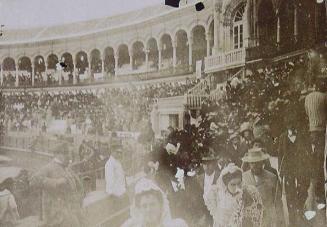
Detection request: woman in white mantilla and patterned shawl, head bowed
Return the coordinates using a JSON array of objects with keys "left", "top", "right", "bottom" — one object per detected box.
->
[{"left": 205, "top": 163, "right": 262, "bottom": 227}]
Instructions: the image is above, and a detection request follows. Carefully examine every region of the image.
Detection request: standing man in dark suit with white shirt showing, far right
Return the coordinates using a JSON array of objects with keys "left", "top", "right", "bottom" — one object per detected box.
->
[{"left": 278, "top": 116, "right": 312, "bottom": 226}]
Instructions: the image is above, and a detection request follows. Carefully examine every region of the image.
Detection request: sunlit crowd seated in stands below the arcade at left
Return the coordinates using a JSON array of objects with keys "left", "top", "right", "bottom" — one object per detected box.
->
[{"left": 4, "top": 80, "right": 196, "bottom": 135}]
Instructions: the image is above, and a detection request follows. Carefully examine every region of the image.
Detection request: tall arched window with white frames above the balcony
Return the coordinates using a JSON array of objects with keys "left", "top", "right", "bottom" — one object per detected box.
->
[{"left": 231, "top": 3, "right": 245, "bottom": 49}]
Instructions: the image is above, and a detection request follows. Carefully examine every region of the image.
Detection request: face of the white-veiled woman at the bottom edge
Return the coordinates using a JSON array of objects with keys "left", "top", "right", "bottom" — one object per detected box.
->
[{"left": 140, "top": 194, "right": 162, "bottom": 226}]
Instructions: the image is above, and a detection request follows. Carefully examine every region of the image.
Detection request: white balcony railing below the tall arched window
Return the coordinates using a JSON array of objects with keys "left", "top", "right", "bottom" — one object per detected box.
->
[{"left": 205, "top": 48, "right": 245, "bottom": 73}]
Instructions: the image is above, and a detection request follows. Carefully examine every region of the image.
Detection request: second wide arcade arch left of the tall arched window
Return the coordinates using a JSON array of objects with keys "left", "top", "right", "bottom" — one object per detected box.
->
[{"left": 176, "top": 30, "right": 188, "bottom": 65}]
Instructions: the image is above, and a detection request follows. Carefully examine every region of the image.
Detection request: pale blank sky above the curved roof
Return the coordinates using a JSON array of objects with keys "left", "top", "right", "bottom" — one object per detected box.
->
[{"left": 0, "top": 0, "right": 165, "bottom": 29}]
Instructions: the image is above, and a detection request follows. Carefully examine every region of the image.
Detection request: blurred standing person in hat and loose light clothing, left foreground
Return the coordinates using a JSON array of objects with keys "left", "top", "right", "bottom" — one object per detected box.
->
[{"left": 31, "top": 142, "right": 83, "bottom": 227}]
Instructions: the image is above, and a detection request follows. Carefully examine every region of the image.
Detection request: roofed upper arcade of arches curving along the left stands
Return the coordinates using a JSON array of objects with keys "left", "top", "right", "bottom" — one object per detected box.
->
[{"left": 0, "top": 2, "right": 213, "bottom": 87}]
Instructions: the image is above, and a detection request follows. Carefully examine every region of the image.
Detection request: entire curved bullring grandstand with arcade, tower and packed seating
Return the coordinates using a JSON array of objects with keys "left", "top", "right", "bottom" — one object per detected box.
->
[{"left": 0, "top": 0, "right": 327, "bottom": 227}]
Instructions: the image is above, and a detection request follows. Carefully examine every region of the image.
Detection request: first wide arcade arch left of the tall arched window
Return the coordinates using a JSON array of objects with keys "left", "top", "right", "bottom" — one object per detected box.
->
[{"left": 192, "top": 25, "right": 207, "bottom": 68}]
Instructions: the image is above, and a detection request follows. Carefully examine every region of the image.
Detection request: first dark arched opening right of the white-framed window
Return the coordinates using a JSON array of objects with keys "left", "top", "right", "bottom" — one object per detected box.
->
[{"left": 258, "top": 0, "right": 277, "bottom": 46}]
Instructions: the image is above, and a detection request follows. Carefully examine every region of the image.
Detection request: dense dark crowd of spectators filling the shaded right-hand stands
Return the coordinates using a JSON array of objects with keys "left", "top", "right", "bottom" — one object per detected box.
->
[{"left": 144, "top": 56, "right": 327, "bottom": 226}]
